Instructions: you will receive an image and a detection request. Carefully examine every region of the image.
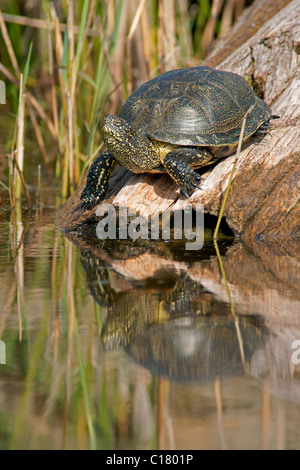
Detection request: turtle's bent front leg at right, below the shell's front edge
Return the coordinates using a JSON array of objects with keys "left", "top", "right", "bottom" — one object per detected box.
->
[{"left": 164, "top": 147, "right": 215, "bottom": 197}]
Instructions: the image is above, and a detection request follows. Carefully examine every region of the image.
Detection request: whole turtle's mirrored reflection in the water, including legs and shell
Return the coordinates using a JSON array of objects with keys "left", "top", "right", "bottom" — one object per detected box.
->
[{"left": 81, "top": 250, "right": 267, "bottom": 380}]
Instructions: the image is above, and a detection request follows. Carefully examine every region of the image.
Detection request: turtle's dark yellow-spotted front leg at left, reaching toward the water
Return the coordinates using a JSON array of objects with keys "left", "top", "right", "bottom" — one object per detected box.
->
[{"left": 80, "top": 150, "right": 116, "bottom": 209}]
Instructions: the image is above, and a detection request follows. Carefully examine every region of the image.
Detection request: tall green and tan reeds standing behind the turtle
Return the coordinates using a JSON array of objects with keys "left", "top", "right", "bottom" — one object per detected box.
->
[{"left": 0, "top": 0, "right": 251, "bottom": 206}]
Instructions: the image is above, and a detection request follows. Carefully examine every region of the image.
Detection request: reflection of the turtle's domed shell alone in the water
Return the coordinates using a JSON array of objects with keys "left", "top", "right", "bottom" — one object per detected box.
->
[{"left": 125, "top": 315, "right": 268, "bottom": 381}]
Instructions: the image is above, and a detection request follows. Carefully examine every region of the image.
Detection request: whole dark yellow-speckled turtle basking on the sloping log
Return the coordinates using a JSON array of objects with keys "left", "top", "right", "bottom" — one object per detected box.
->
[{"left": 81, "top": 66, "right": 271, "bottom": 209}]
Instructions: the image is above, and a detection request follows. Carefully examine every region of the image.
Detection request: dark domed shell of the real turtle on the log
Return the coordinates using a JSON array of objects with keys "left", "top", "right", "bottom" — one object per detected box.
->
[{"left": 119, "top": 67, "right": 271, "bottom": 147}]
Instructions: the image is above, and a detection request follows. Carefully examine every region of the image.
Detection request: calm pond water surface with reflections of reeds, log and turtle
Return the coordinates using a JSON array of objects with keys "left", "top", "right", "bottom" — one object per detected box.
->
[{"left": 0, "top": 196, "right": 300, "bottom": 450}]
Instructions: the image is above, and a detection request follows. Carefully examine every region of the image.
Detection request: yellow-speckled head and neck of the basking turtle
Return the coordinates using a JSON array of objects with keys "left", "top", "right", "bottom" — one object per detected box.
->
[{"left": 101, "top": 115, "right": 160, "bottom": 173}]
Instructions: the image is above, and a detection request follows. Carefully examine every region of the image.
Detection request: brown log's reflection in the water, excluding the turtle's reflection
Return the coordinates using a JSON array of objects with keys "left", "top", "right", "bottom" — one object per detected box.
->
[{"left": 68, "top": 223, "right": 300, "bottom": 326}]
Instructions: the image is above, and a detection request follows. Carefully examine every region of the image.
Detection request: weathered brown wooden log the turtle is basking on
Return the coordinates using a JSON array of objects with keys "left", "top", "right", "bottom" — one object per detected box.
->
[{"left": 57, "top": 0, "right": 300, "bottom": 241}]
